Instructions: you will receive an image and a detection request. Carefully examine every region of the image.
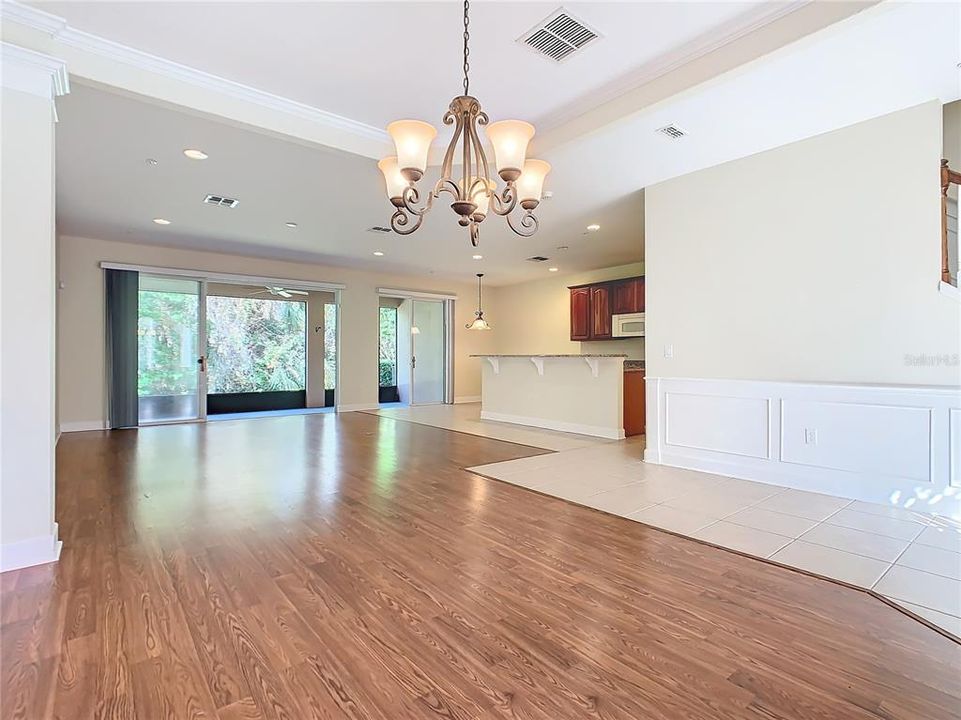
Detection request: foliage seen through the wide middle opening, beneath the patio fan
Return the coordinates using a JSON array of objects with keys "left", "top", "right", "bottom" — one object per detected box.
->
[{"left": 207, "top": 296, "right": 307, "bottom": 393}]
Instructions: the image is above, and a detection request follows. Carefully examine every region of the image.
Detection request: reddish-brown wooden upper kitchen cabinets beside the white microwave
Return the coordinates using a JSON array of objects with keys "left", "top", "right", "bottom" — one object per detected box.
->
[{"left": 569, "top": 277, "right": 644, "bottom": 341}]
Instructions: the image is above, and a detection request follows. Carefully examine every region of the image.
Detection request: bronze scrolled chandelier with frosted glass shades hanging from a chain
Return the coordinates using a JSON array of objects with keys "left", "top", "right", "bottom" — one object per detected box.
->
[{"left": 377, "top": 0, "right": 551, "bottom": 246}]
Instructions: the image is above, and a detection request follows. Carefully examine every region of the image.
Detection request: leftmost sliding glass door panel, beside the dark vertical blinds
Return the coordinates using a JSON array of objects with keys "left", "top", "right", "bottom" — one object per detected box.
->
[{"left": 137, "top": 273, "right": 206, "bottom": 425}]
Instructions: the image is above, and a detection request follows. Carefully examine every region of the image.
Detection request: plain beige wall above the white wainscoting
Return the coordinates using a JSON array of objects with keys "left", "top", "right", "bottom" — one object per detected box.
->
[{"left": 645, "top": 102, "right": 961, "bottom": 385}]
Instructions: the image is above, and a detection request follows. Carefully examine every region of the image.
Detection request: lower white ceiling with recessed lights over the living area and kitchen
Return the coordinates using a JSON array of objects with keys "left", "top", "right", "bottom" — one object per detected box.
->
[{"left": 57, "top": 83, "right": 643, "bottom": 285}]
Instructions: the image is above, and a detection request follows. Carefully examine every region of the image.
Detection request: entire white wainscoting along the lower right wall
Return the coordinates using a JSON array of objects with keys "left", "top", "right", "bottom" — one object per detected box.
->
[{"left": 644, "top": 377, "right": 961, "bottom": 518}]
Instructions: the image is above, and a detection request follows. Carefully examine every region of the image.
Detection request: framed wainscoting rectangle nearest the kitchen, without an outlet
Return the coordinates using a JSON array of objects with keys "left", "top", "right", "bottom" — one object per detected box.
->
[{"left": 664, "top": 392, "right": 770, "bottom": 458}]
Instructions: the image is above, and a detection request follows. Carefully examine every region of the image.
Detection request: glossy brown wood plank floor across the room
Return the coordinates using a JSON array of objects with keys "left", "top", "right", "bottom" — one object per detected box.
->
[{"left": 0, "top": 413, "right": 961, "bottom": 720}]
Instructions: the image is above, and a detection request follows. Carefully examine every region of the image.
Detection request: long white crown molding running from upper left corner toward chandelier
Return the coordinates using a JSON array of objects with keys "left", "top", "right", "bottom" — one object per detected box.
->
[{"left": 0, "top": 0, "right": 390, "bottom": 149}]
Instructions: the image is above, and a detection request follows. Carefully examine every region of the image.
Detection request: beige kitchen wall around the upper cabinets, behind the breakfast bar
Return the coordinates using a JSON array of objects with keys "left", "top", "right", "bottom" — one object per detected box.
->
[{"left": 484, "top": 262, "right": 644, "bottom": 359}]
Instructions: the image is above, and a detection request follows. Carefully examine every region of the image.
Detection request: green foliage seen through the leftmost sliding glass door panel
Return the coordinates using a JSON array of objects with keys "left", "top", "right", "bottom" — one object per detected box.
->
[{"left": 137, "top": 290, "right": 198, "bottom": 397}]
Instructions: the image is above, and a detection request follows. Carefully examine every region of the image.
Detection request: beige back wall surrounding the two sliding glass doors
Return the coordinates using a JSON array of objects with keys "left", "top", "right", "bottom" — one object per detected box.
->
[{"left": 58, "top": 237, "right": 493, "bottom": 427}]
